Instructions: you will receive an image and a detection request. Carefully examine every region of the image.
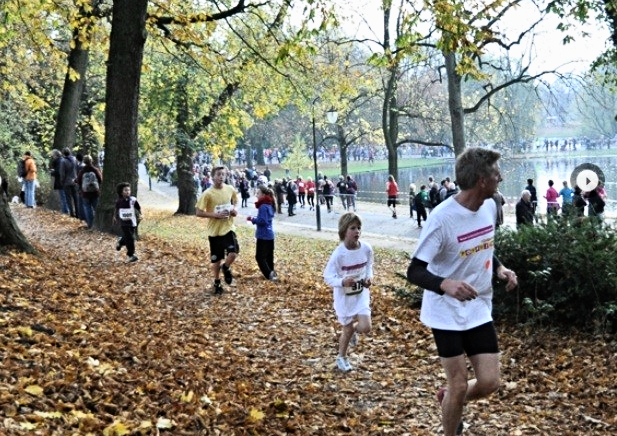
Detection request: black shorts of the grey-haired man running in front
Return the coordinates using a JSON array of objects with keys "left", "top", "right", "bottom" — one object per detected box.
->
[{"left": 432, "top": 321, "right": 499, "bottom": 358}]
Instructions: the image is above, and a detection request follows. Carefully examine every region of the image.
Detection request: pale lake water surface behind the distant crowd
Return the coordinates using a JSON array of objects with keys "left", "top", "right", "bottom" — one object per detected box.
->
[{"left": 355, "top": 155, "right": 617, "bottom": 212}]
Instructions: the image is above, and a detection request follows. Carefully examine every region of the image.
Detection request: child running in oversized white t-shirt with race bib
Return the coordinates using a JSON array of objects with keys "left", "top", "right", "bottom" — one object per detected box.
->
[{"left": 324, "top": 212, "right": 374, "bottom": 372}]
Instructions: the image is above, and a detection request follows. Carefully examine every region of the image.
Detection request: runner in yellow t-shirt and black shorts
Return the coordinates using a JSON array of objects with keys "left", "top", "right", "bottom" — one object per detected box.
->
[{"left": 195, "top": 167, "right": 240, "bottom": 295}]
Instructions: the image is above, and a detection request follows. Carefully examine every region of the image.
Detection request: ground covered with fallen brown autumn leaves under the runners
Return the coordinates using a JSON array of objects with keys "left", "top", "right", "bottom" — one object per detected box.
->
[{"left": 0, "top": 207, "right": 617, "bottom": 436}]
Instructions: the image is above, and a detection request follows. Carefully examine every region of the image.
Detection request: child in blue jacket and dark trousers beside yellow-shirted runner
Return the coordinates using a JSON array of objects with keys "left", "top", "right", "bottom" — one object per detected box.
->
[{"left": 246, "top": 185, "right": 278, "bottom": 281}]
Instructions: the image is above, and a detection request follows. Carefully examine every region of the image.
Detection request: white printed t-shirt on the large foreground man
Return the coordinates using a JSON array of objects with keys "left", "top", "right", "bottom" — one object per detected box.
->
[{"left": 413, "top": 197, "right": 496, "bottom": 331}]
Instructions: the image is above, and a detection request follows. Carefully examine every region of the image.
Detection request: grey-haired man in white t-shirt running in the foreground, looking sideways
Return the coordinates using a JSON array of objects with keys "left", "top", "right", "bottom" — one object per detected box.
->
[{"left": 407, "top": 148, "right": 517, "bottom": 436}]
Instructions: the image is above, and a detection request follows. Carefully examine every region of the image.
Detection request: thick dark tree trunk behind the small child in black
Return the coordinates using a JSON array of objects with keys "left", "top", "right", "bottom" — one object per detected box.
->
[{"left": 94, "top": 0, "right": 148, "bottom": 232}]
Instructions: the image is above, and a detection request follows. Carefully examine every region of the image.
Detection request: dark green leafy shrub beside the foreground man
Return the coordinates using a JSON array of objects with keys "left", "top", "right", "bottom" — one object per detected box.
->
[{"left": 494, "top": 221, "right": 617, "bottom": 332}]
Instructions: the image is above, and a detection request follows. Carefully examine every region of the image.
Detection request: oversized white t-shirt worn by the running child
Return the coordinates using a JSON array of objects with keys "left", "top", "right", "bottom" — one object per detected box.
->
[{"left": 323, "top": 241, "right": 373, "bottom": 325}]
